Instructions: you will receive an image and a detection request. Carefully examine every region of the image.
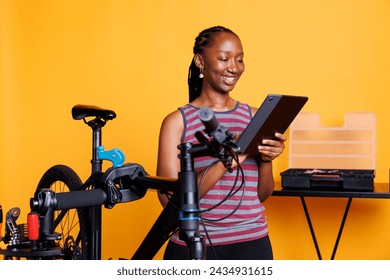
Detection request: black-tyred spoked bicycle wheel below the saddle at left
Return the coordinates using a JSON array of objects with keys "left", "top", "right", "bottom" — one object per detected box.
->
[{"left": 37, "top": 165, "right": 90, "bottom": 260}]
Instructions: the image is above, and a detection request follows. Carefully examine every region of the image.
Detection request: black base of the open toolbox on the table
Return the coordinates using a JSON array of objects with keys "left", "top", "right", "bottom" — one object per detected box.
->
[{"left": 280, "top": 168, "right": 375, "bottom": 192}]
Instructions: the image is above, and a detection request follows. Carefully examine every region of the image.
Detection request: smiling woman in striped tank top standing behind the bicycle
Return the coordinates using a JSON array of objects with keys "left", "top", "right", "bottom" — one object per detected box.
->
[{"left": 157, "top": 26, "right": 286, "bottom": 259}]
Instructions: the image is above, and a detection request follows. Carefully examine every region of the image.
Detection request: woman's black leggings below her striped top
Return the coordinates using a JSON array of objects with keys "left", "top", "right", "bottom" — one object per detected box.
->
[{"left": 164, "top": 235, "right": 273, "bottom": 260}]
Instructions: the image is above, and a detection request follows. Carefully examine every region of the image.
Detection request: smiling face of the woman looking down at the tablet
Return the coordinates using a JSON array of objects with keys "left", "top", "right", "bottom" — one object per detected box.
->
[{"left": 194, "top": 32, "right": 245, "bottom": 94}]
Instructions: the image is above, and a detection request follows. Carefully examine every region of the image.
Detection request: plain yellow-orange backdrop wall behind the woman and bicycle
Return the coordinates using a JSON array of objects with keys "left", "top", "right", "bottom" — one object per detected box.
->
[{"left": 0, "top": 0, "right": 390, "bottom": 259}]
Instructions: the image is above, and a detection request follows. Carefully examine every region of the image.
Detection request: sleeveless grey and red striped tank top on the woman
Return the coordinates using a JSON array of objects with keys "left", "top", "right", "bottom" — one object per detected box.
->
[{"left": 171, "top": 102, "right": 268, "bottom": 245}]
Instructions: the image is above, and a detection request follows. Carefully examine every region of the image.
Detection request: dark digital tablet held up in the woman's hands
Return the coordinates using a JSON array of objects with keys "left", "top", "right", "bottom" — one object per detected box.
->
[{"left": 237, "top": 94, "right": 308, "bottom": 154}]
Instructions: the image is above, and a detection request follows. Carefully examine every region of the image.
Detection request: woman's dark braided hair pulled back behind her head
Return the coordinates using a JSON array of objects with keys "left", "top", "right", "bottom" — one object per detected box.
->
[{"left": 188, "top": 26, "right": 238, "bottom": 102}]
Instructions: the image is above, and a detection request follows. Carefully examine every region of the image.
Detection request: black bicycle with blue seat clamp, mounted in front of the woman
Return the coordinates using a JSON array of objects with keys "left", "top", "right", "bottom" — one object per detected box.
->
[{"left": 0, "top": 105, "right": 238, "bottom": 260}]
